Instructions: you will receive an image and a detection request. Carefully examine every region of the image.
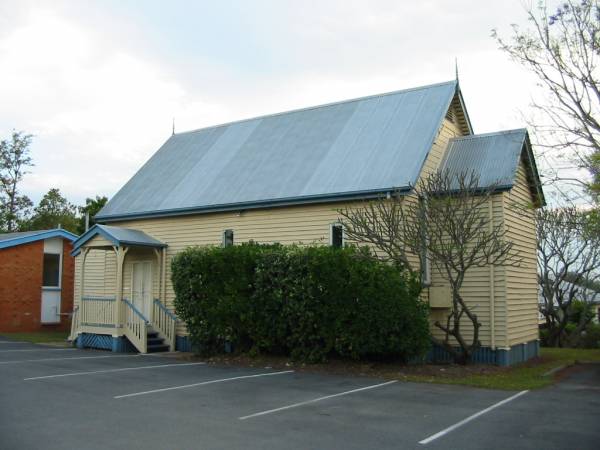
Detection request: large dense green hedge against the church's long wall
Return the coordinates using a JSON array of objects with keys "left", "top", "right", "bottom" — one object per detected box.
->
[{"left": 172, "top": 244, "right": 430, "bottom": 362}]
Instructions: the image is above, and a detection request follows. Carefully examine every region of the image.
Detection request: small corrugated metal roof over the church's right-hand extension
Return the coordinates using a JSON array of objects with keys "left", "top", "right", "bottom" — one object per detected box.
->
[{"left": 440, "top": 129, "right": 527, "bottom": 188}]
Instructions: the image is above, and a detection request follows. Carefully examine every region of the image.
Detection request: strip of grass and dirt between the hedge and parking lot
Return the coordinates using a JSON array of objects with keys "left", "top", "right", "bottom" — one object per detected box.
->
[{"left": 182, "top": 348, "right": 600, "bottom": 391}]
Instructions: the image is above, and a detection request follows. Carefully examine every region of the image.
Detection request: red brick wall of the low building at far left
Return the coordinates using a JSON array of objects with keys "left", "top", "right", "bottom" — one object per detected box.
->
[{"left": 0, "top": 240, "right": 74, "bottom": 333}]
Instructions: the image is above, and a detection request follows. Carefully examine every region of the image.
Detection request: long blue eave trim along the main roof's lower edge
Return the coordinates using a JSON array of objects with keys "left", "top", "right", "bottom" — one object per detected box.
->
[{"left": 95, "top": 186, "right": 412, "bottom": 222}]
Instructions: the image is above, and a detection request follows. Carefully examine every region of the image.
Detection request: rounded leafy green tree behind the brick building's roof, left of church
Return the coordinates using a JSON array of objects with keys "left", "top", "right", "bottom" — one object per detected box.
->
[{"left": 26, "top": 188, "right": 79, "bottom": 233}]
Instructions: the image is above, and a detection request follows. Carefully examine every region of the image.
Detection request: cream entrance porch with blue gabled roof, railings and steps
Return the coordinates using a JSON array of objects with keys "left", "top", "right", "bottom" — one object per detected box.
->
[{"left": 71, "top": 225, "right": 177, "bottom": 353}]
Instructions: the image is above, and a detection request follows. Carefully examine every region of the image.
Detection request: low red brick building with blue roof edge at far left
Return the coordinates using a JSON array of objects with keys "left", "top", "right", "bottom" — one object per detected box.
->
[{"left": 0, "top": 229, "right": 77, "bottom": 333}]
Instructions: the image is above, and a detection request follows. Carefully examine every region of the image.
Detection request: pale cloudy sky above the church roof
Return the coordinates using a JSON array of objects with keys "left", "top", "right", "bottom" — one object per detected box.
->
[{"left": 0, "top": 0, "right": 556, "bottom": 204}]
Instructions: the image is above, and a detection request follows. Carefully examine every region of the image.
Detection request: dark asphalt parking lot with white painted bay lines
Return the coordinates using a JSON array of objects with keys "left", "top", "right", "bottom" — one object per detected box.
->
[{"left": 0, "top": 338, "right": 600, "bottom": 450}]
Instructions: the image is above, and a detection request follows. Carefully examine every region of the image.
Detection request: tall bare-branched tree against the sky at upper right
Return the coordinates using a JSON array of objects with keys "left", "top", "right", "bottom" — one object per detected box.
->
[{"left": 492, "top": 0, "right": 600, "bottom": 196}]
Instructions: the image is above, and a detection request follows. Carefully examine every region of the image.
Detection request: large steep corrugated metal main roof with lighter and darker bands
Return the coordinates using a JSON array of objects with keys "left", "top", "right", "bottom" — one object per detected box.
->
[{"left": 97, "top": 81, "right": 457, "bottom": 220}]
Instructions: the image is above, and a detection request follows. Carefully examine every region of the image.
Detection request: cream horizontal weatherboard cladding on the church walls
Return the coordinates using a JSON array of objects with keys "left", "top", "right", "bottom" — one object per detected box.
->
[{"left": 75, "top": 114, "right": 537, "bottom": 348}]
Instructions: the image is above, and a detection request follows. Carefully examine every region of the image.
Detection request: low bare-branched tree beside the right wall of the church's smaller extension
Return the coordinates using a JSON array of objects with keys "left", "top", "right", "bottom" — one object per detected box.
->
[{"left": 536, "top": 207, "right": 600, "bottom": 346}]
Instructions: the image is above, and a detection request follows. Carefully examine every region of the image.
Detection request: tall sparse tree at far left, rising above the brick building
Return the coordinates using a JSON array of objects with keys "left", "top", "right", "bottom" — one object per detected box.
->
[{"left": 0, "top": 131, "right": 33, "bottom": 232}]
